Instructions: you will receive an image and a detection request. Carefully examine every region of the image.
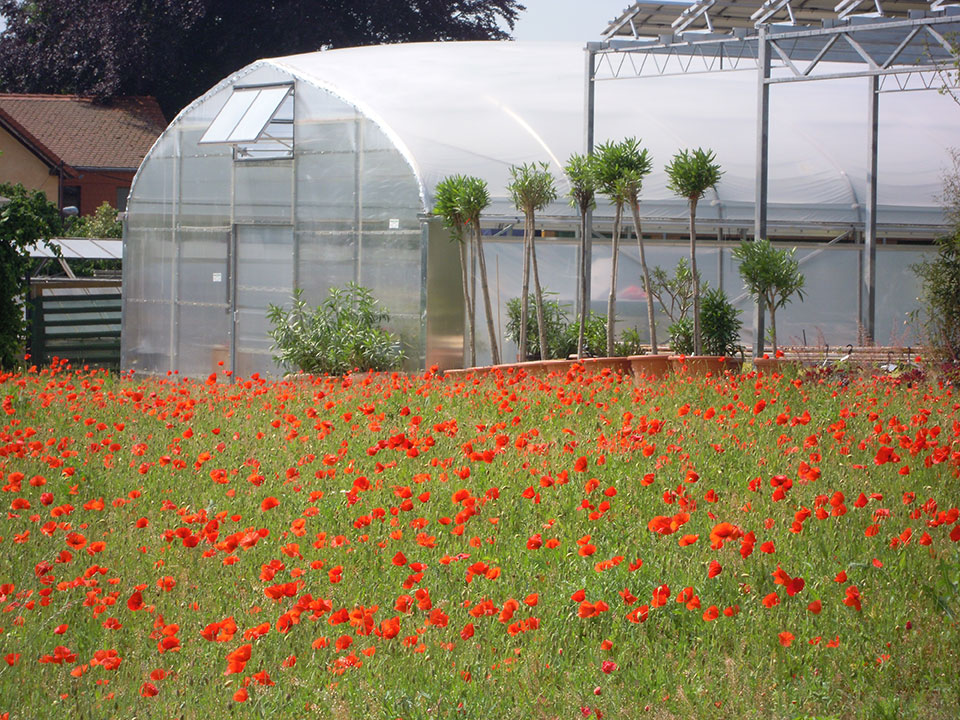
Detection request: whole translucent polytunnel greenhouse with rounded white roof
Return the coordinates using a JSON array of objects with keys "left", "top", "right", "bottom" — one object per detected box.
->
[{"left": 122, "top": 42, "right": 960, "bottom": 377}]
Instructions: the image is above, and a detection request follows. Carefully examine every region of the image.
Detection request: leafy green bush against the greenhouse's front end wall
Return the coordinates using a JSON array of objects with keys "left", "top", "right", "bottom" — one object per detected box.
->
[{"left": 267, "top": 283, "right": 404, "bottom": 375}]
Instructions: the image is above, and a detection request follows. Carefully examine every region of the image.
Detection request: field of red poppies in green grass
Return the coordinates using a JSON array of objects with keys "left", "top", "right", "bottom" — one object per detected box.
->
[{"left": 0, "top": 365, "right": 960, "bottom": 720}]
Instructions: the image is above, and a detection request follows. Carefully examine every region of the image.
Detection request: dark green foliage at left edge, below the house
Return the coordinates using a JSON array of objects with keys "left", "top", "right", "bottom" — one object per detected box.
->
[{"left": 0, "top": 184, "right": 61, "bottom": 369}]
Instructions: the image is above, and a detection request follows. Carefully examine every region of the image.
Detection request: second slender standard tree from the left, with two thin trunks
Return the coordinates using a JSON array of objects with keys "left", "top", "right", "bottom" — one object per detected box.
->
[{"left": 507, "top": 163, "right": 557, "bottom": 362}]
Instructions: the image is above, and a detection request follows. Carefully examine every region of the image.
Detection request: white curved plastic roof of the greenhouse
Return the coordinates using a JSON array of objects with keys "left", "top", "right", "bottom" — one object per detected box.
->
[{"left": 204, "top": 42, "right": 960, "bottom": 227}]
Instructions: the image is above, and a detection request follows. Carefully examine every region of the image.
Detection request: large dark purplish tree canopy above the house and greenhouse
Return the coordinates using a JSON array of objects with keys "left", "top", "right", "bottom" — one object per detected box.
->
[{"left": 0, "top": 0, "right": 526, "bottom": 117}]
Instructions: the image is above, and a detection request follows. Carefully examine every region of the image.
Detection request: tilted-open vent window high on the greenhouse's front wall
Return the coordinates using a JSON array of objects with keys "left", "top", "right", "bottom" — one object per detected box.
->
[{"left": 200, "top": 83, "right": 293, "bottom": 160}]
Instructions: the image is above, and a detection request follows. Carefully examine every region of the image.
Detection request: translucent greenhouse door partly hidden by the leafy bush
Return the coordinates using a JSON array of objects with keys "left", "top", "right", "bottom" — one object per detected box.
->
[{"left": 230, "top": 225, "right": 293, "bottom": 377}]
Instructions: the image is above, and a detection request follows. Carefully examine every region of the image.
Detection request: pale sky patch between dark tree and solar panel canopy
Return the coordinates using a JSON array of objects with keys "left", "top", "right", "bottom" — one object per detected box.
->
[{"left": 513, "top": 0, "right": 633, "bottom": 42}]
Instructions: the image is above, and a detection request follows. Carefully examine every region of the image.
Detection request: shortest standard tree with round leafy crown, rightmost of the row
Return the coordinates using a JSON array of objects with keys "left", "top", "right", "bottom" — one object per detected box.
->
[{"left": 733, "top": 239, "right": 803, "bottom": 354}]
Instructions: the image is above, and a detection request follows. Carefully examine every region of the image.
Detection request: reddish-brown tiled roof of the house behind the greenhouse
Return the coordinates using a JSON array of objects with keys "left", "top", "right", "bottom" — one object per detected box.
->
[{"left": 0, "top": 94, "right": 167, "bottom": 170}]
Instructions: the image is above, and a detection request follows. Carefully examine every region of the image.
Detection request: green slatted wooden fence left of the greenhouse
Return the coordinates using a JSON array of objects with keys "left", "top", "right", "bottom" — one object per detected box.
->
[{"left": 27, "top": 278, "right": 121, "bottom": 370}]
